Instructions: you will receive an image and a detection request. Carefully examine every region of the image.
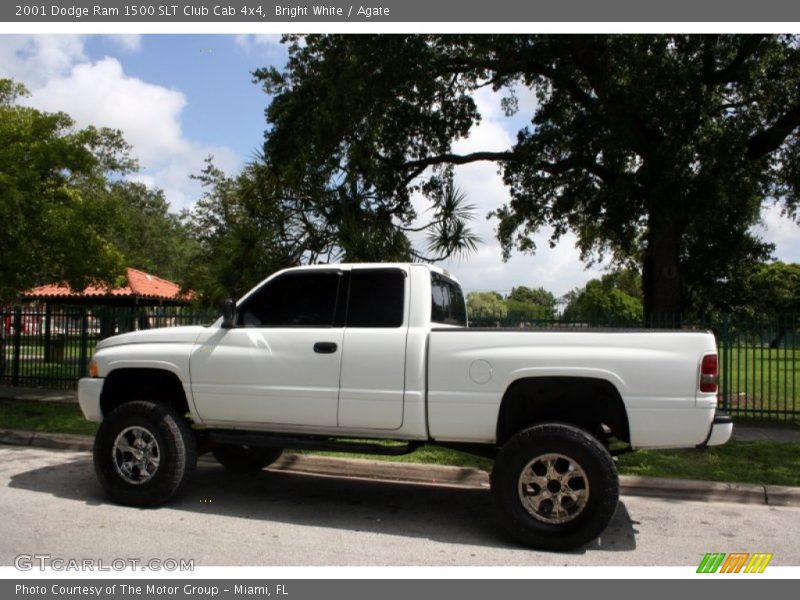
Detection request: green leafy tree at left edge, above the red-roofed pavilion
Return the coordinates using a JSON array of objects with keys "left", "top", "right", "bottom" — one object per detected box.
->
[{"left": 0, "top": 80, "right": 135, "bottom": 301}]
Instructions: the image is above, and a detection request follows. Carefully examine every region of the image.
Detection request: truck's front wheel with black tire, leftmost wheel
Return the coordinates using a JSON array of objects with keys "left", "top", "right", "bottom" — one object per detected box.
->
[{"left": 94, "top": 400, "right": 197, "bottom": 507}]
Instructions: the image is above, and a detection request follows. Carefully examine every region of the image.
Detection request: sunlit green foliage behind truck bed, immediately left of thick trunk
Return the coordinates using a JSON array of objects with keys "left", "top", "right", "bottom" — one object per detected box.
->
[{"left": 564, "top": 270, "right": 644, "bottom": 324}]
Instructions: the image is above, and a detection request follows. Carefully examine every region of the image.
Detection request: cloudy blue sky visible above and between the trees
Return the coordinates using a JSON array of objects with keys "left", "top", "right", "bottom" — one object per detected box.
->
[{"left": 0, "top": 34, "right": 800, "bottom": 295}]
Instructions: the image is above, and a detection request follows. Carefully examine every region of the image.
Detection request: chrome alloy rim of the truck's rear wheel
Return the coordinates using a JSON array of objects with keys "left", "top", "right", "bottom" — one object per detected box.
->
[{"left": 517, "top": 454, "right": 589, "bottom": 525}]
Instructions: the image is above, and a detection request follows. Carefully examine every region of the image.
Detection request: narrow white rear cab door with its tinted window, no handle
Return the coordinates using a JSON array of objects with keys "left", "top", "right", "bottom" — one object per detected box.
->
[{"left": 339, "top": 268, "right": 409, "bottom": 429}]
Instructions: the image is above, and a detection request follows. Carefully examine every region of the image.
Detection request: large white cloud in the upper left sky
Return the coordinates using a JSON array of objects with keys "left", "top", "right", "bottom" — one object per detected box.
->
[{"left": 0, "top": 35, "right": 240, "bottom": 210}]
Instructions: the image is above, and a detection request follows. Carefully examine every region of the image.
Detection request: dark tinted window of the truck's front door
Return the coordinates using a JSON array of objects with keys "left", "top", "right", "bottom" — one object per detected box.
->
[{"left": 239, "top": 271, "right": 342, "bottom": 327}]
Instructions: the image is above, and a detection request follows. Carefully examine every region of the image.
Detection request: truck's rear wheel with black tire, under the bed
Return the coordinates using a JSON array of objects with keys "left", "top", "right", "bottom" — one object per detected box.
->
[{"left": 491, "top": 423, "right": 619, "bottom": 550}]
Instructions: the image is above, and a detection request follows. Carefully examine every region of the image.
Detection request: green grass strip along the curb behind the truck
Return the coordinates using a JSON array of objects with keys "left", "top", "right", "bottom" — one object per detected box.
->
[{"left": 0, "top": 400, "right": 800, "bottom": 486}]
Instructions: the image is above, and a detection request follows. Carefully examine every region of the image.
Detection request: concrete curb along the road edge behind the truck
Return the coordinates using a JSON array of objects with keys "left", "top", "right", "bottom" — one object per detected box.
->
[{"left": 0, "top": 429, "right": 800, "bottom": 506}]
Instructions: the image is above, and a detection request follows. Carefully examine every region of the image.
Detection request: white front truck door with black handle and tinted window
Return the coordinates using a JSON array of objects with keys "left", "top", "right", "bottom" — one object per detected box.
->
[{"left": 190, "top": 269, "right": 346, "bottom": 427}]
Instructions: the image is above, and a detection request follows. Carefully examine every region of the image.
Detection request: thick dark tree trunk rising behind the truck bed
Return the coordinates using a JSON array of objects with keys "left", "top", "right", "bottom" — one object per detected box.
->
[{"left": 642, "top": 214, "right": 683, "bottom": 327}]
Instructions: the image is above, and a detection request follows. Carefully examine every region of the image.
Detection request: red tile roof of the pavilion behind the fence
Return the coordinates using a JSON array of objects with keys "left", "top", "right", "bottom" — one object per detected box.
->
[{"left": 22, "top": 267, "right": 194, "bottom": 301}]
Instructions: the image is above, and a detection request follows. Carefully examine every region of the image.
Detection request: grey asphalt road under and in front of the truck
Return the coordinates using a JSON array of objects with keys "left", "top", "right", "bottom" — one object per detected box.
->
[{"left": 0, "top": 446, "right": 800, "bottom": 566}]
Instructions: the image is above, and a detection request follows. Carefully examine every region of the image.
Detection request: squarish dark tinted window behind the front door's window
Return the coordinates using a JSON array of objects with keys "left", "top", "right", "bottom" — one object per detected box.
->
[{"left": 347, "top": 269, "right": 406, "bottom": 327}]
